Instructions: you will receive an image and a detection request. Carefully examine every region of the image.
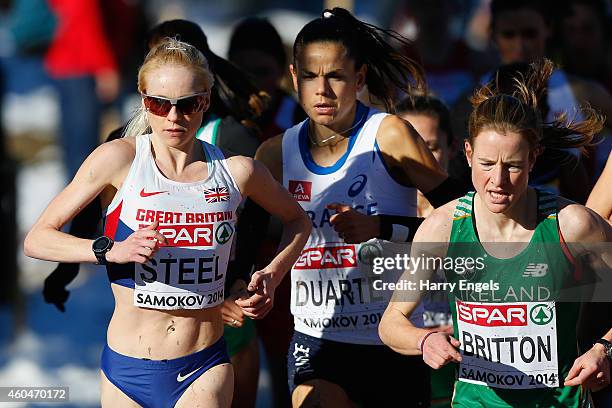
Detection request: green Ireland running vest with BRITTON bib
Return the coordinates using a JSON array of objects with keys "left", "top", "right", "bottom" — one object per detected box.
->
[{"left": 446, "top": 190, "right": 581, "bottom": 408}]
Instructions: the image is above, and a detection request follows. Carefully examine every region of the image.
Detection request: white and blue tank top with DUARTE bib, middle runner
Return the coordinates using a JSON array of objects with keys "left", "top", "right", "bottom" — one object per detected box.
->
[{"left": 282, "top": 104, "right": 417, "bottom": 345}]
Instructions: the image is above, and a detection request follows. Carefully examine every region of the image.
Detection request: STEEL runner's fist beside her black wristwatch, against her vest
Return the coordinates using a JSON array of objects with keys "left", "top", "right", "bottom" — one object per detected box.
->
[{"left": 106, "top": 221, "right": 166, "bottom": 264}]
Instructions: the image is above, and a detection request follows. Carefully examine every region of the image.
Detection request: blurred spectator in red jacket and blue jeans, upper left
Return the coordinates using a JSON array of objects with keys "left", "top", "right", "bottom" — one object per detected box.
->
[{"left": 45, "top": 0, "right": 119, "bottom": 178}]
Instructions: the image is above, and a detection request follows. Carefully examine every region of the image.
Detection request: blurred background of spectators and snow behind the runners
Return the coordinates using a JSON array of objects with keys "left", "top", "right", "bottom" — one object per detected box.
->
[{"left": 0, "top": 0, "right": 612, "bottom": 407}]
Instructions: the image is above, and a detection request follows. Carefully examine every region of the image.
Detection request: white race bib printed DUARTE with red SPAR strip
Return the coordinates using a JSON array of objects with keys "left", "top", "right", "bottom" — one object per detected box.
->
[{"left": 291, "top": 240, "right": 423, "bottom": 344}]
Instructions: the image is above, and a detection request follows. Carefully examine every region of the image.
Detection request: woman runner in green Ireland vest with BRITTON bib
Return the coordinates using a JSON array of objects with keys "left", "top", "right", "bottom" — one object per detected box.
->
[{"left": 379, "top": 61, "right": 612, "bottom": 408}]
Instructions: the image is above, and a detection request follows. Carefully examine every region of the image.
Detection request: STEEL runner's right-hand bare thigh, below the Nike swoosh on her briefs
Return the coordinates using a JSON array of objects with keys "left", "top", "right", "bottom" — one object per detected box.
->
[{"left": 175, "top": 364, "right": 234, "bottom": 408}]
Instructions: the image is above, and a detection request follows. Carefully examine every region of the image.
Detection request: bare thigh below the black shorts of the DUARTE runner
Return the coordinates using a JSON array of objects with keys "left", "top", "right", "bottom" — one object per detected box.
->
[{"left": 291, "top": 379, "right": 355, "bottom": 408}]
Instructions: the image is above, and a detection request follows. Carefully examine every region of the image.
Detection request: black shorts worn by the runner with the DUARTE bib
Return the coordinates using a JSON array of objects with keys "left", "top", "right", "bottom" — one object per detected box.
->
[{"left": 287, "top": 332, "right": 431, "bottom": 407}]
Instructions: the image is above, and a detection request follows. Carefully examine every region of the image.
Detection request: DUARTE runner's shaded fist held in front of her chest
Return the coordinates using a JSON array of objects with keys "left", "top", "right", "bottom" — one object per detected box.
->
[{"left": 325, "top": 203, "right": 380, "bottom": 244}]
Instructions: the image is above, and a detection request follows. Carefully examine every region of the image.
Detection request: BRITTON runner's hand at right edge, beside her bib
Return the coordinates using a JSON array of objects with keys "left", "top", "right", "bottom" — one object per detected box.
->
[{"left": 563, "top": 344, "right": 610, "bottom": 391}]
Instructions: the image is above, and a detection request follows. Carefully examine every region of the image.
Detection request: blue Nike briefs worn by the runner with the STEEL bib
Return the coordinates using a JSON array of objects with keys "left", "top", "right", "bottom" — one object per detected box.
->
[{"left": 101, "top": 337, "right": 230, "bottom": 408}]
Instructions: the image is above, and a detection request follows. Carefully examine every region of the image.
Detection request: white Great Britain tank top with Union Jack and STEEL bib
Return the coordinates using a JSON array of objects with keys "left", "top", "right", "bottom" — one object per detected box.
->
[{"left": 105, "top": 134, "right": 242, "bottom": 309}]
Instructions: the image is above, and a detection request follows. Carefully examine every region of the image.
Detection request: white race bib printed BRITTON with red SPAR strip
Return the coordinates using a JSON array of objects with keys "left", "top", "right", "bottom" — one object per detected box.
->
[{"left": 455, "top": 300, "right": 559, "bottom": 389}]
